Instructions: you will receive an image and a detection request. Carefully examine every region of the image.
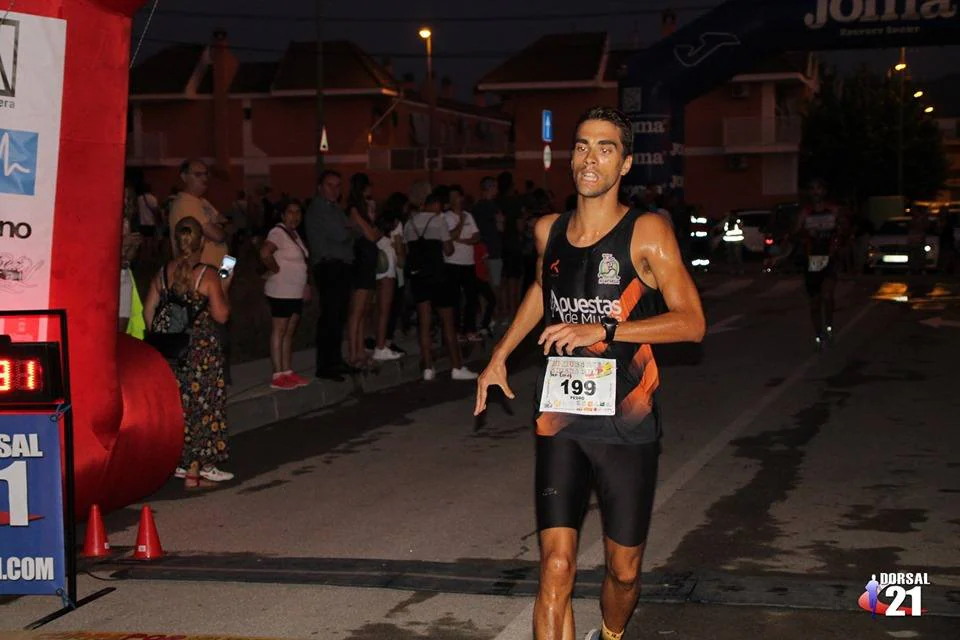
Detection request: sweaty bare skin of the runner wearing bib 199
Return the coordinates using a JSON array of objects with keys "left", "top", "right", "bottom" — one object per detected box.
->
[{"left": 474, "top": 114, "right": 706, "bottom": 640}]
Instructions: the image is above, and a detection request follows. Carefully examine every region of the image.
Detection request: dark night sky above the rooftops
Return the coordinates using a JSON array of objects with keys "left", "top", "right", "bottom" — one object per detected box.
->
[{"left": 133, "top": 0, "right": 960, "bottom": 99}]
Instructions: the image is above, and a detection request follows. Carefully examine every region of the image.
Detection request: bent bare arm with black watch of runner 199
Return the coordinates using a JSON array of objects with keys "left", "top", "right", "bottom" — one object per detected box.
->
[{"left": 614, "top": 216, "right": 706, "bottom": 344}]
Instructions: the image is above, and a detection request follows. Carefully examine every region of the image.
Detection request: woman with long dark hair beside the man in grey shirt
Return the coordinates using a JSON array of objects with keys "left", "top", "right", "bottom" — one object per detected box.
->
[{"left": 347, "top": 173, "right": 383, "bottom": 367}]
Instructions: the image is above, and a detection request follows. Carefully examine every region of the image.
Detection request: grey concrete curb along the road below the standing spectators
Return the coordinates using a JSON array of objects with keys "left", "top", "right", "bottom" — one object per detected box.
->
[{"left": 227, "top": 341, "right": 494, "bottom": 436}]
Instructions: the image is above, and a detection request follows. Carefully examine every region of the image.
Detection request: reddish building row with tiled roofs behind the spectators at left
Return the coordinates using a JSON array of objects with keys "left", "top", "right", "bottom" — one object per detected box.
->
[{"left": 127, "top": 32, "right": 513, "bottom": 206}]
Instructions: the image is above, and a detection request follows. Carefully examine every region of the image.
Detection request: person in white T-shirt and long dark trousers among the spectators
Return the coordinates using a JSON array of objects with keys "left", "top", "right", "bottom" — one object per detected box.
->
[{"left": 443, "top": 184, "right": 482, "bottom": 342}]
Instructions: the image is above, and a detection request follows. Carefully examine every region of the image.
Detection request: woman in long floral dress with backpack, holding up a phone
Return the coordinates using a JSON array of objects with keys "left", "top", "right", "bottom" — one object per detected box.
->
[{"left": 143, "top": 218, "right": 233, "bottom": 489}]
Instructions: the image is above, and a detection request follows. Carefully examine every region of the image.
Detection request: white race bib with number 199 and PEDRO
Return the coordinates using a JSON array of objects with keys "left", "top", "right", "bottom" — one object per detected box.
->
[{"left": 540, "top": 357, "right": 617, "bottom": 416}]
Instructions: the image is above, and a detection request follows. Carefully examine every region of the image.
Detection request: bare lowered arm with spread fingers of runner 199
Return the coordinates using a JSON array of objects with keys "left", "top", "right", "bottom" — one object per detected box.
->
[{"left": 473, "top": 213, "right": 559, "bottom": 416}]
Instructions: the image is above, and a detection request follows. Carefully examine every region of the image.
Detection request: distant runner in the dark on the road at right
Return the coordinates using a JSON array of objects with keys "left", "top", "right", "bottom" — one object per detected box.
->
[{"left": 796, "top": 178, "right": 840, "bottom": 350}]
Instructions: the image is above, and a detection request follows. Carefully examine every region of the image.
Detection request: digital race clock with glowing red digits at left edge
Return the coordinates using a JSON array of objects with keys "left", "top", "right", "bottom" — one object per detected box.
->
[{"left": 0, "top": 336, "right": 63, "bottom": 406}]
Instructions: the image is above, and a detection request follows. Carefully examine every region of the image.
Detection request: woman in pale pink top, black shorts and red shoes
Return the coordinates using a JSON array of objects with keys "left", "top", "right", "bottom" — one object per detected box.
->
[{"left": 260, "top": 200, "right": 311, "bottom": 390}]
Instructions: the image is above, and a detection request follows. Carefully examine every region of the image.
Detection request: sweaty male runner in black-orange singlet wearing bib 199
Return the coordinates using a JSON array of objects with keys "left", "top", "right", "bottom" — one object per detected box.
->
[{"left": 474, "top": 107, "right": 705, "bottom": 640}]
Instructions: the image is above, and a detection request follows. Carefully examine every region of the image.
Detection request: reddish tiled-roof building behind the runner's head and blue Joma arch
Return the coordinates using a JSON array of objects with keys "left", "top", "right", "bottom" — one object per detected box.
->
[{"left": 476, "top": 22, "right": 817, "bottom": 216}]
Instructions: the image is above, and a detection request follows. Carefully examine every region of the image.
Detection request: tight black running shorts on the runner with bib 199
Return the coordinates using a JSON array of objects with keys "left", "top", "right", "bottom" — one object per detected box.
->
[{"left": 536, "top": 435, "right": 660, "bottom": 547}]
